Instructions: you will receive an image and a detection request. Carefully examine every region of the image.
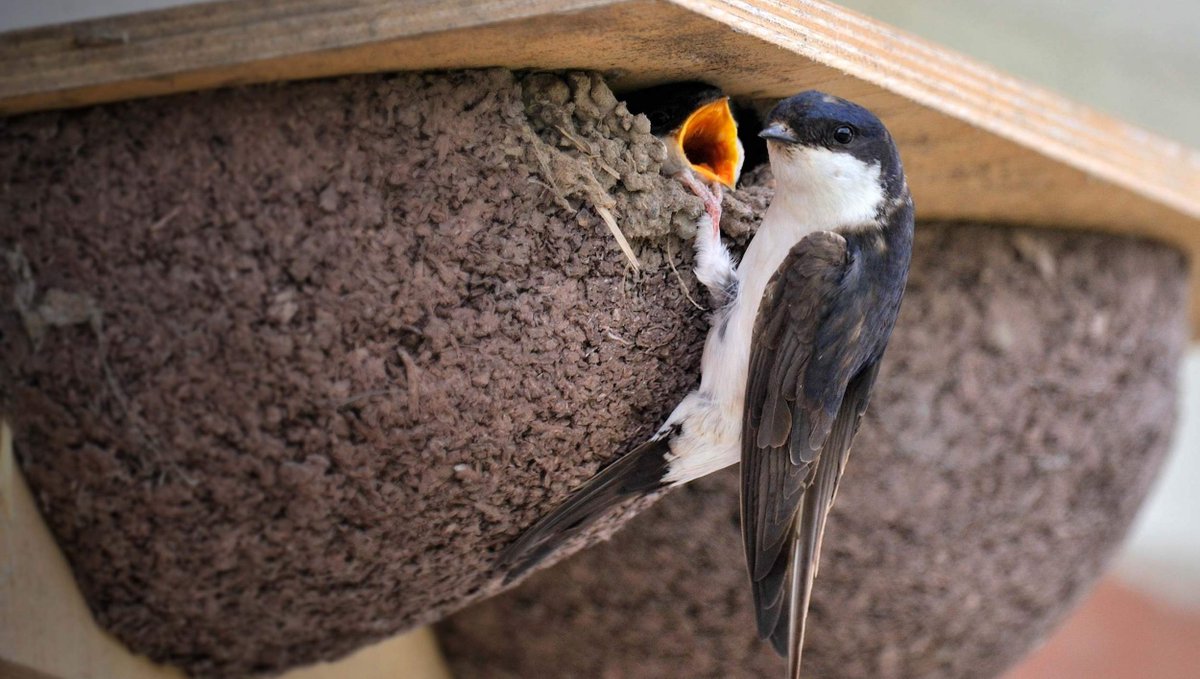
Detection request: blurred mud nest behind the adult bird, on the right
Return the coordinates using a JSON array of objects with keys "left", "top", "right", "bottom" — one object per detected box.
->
[{"left": 438, "top": 224, "right": 1187, "bottom": 679}]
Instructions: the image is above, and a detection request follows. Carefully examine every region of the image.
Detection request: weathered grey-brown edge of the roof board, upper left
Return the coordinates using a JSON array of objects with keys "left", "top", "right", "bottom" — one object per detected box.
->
[{"left": 0, "top": 0, "right": 613, "bottom": 115}]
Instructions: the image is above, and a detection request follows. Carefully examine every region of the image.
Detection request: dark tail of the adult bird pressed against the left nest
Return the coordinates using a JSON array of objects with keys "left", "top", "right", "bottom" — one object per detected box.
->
[{"left": 497, "top": 435, "right": 671, "bottom": 584}]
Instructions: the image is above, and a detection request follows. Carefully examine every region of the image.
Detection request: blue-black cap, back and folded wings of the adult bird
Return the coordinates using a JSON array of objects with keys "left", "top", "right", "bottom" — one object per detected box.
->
[{"left": 742, "top": 92, "right": 913, "bottom": 677}]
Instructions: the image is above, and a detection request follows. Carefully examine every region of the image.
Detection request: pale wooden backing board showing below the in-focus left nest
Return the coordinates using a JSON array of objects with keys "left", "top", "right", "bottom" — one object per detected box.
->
[{"left": 0, "top": 420, "right": 450, "bottom": 679}]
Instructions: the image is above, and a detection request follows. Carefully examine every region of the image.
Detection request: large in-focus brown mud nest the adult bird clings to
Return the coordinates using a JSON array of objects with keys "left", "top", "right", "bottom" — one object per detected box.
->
[{"left": 0, "top": 71, "right": 766, "bottom": 675}]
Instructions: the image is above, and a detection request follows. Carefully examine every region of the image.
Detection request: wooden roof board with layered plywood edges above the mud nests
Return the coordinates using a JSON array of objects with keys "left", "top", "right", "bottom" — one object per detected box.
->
[{"left": 0, "top": 0, "right": 1200, "bottom": 331}]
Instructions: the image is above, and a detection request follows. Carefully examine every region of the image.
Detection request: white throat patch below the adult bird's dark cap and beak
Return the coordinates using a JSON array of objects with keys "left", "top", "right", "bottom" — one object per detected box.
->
[{"left": 768, "top": 143, "right": 883, "bottom": 230}]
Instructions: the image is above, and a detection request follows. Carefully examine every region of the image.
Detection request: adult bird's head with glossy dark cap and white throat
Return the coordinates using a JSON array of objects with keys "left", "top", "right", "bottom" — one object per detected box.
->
[{"left": 758, "top": 90, "right": 907, "bottom": 217}]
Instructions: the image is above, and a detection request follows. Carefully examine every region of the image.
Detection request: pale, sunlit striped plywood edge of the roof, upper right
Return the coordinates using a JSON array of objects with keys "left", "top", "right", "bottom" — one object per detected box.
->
[{"left": 673, "top": 0, "right": 1200, "bottom": 224}]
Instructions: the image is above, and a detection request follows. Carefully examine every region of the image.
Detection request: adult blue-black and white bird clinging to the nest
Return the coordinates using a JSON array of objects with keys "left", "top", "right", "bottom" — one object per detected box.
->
[{"left": 499, "top": 91, "right": 913, "bottom": 678}]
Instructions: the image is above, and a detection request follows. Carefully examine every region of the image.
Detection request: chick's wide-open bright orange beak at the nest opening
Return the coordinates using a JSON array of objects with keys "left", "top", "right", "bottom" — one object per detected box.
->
[{"left": 676, "top": 97, "right": 743, "bottom": 188}]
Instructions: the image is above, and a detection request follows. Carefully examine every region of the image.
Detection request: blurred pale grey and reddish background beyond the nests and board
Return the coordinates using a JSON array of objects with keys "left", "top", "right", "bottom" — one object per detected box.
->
[{"left": 0, "top": 0, "right": 1200, "bottom": 679}]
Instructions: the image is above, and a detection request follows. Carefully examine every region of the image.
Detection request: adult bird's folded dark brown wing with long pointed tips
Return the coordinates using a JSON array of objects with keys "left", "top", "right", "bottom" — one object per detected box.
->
[{"left": 742, "top": 232, "right": 878, "bottom": 677}]
